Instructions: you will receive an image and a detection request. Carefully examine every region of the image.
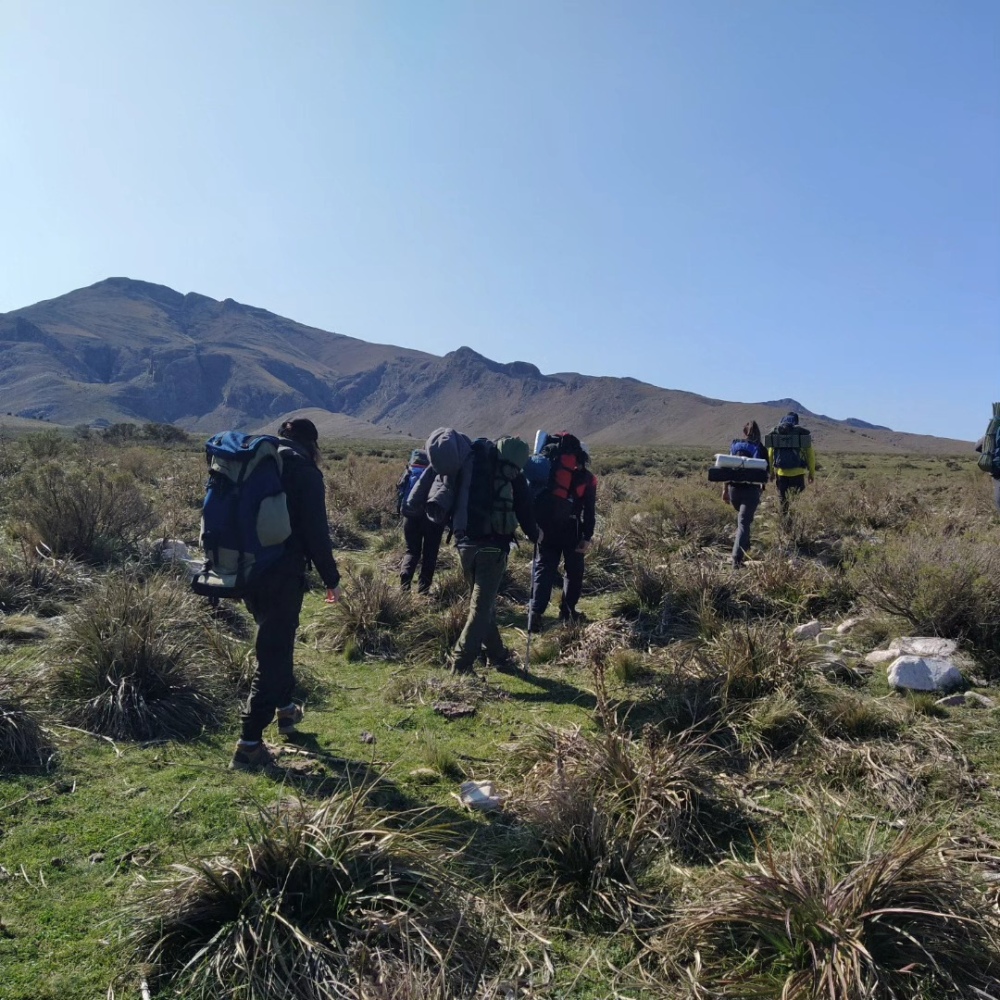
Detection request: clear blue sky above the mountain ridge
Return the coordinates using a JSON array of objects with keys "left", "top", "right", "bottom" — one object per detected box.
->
[{"left": 0, "top": 0, "right": 1000, "bottom": 439}]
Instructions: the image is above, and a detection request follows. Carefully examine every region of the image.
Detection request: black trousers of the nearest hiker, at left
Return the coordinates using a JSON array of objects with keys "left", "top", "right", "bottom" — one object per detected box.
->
[{"left": 241, "top": 573, "right": 306, "bottom": 741}]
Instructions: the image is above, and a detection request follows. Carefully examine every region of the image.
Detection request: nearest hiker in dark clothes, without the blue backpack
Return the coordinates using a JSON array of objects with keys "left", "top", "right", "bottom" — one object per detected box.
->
[{"left": 230, "top": 417, "right": 341, "bottom": 771}]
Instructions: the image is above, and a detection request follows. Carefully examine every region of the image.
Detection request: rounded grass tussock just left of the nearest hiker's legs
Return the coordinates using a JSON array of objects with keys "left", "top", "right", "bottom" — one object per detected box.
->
[{"left": 43, "top": 576, "right": 224, "bottom": 740}]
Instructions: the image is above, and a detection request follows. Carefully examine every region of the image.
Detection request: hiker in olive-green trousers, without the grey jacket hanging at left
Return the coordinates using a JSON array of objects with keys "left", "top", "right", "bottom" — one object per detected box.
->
[{"left": 448, "top": 437, "right": 538, "bottom": 674}]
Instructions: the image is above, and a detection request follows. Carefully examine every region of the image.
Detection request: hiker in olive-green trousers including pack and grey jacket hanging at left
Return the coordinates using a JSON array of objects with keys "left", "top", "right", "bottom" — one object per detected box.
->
[{"left": 407, "top": 427, "right": 538, "bottom": 674}]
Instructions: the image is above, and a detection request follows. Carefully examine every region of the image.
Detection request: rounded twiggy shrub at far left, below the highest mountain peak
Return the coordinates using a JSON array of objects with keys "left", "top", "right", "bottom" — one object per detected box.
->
[{"left": 17, "top": 465, "right": 156, "bottom": 562}]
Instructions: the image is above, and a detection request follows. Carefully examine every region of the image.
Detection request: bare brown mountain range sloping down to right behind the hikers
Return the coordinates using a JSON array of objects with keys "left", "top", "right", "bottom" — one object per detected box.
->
[{"left": 0, "top": 278, "right": 970, "bottom": 452}]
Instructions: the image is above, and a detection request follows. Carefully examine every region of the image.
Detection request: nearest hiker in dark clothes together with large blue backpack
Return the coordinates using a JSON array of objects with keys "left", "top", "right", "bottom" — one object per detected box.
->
[{"left": 192, "top": 418, "right": 340, "bottom": 771}]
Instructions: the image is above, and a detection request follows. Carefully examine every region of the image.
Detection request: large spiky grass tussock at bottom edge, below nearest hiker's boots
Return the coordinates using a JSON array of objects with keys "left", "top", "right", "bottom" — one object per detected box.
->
[{"left": 131, "top": 794, "right": 493, "bottom": 1000}]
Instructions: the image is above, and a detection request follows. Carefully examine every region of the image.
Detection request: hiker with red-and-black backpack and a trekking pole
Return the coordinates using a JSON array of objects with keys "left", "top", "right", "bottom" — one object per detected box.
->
[{"left": 528, "top": 431, "right": 597, "bottom": 632}]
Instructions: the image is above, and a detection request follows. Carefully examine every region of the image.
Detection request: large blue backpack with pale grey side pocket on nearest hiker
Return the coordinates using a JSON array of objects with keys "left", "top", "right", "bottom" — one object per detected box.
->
[{"left": 191, "top": 431, "right": 292, "bottom": 597}]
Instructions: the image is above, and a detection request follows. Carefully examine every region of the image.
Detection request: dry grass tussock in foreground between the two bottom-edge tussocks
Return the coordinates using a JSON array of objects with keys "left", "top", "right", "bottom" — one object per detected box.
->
[{"left": 511, "top": 728, "right": 734, "bottom": 928}]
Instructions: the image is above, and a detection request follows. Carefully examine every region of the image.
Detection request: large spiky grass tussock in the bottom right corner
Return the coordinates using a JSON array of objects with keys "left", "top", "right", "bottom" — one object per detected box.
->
[{"left": 666, "top": 824, "right": 1000, "bottom": 1000}]
